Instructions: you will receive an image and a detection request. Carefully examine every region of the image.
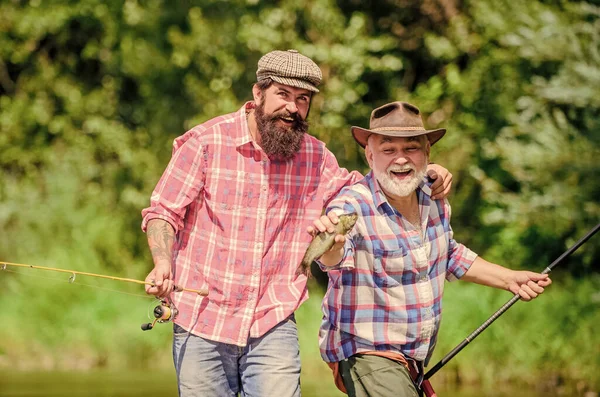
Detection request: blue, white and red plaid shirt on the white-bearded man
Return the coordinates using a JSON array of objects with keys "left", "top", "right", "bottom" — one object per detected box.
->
[{"left": 319, "top": 172, "right": 477, "bottom": 362}]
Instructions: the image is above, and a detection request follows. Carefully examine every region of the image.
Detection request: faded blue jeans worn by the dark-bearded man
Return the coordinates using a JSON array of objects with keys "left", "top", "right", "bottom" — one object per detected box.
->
[{"left": 173, "top": 316, "right": 300, "bottom": 397}]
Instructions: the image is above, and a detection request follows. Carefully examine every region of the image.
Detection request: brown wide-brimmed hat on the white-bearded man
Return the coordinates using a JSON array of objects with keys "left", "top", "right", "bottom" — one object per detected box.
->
[{"left": 350, "top": 102, "right": 446, "bottom": 147}]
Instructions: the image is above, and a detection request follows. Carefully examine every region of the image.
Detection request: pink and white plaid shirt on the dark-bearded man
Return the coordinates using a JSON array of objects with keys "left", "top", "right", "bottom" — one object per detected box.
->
[{"left": 142, "top": 102, "right": 361, "bottom": 346}]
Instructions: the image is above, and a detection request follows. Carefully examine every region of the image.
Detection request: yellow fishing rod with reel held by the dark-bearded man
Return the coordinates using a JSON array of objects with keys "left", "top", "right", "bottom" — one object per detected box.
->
[{"left": 0, "top": 262, "right": 208, "bottom": 331}]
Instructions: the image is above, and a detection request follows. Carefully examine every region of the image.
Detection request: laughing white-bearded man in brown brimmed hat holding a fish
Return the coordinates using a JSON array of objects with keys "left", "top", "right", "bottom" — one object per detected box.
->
[{"left": 307, "top": 102, "right": 551, "bottom": 397}]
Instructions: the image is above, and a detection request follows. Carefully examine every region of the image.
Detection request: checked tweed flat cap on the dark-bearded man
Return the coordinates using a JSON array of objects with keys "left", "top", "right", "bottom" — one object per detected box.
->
[{"left": 256, "top": 50, "right": 323, "bottom": 92}]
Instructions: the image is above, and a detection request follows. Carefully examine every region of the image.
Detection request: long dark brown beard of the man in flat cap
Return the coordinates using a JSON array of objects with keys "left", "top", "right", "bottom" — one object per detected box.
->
[{"left": 254, "top": 102, "right": 308, "bottom": 161}]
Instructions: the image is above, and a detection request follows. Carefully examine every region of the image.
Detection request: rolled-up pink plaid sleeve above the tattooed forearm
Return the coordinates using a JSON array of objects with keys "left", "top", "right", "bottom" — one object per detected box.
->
[{"left": 142, "top": 132, "right": 206, "bottom": 233}]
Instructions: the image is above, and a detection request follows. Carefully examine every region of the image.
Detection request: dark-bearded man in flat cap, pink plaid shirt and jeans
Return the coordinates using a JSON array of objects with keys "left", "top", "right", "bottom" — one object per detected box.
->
[{"left": 142, "top": 50, "right": 451, "bottom": 397}]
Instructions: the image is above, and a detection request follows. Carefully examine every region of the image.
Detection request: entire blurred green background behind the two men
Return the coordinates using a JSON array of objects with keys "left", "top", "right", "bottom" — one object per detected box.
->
[{"left": 0, "top": 0, "right": 600, "bottom": 397}]
